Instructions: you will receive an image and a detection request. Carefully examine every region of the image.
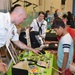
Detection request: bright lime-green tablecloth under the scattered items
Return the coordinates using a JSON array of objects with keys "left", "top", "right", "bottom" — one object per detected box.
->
[{"left": 8, "top": 51, "right": 56, "bottom": 75}]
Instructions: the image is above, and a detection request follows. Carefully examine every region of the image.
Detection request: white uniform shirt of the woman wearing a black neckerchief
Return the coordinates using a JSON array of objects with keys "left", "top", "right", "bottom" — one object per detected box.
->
[{"left": 30, "top": 18, "right": 47, "bottom": 38}]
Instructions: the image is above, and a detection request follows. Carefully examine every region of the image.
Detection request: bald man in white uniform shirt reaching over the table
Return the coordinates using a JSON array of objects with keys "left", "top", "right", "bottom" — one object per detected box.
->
[{"left": 0, "top": 6, "right": 38, "bottom": 72}]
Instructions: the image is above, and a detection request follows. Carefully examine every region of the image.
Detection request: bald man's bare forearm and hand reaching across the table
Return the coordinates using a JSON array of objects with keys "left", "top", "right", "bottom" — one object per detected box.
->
[{"left": 13, "top": 40, "right": 39, "bottom": 54}]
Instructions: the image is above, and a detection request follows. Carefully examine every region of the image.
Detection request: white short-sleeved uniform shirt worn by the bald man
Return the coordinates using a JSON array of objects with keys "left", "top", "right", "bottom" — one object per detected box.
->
[{"left": 0, "top": 13, "right": 19, "bottom": 47}]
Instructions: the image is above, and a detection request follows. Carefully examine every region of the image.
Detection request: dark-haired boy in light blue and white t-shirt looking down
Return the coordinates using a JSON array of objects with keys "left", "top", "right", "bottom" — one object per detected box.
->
[{"left": 52, "top": 17, "right": 74, "bottom": 75}]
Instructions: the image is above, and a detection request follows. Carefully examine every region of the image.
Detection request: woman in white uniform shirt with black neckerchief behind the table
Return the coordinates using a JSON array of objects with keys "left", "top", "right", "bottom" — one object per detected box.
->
[{"left": 30, "top": 11, "right": 47, "bottom": 48}]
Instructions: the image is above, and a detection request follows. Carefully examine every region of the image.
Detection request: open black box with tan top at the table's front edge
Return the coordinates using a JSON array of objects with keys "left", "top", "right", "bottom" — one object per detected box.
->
[{"left": 12, "top": 61, "right": 29, "bottom": 75}]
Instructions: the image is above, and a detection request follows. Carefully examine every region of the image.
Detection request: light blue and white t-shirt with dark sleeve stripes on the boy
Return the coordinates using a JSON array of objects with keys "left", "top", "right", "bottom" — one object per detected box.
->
[{"left": 57, "top": 33, "right": 74, "bottom": 68}]
